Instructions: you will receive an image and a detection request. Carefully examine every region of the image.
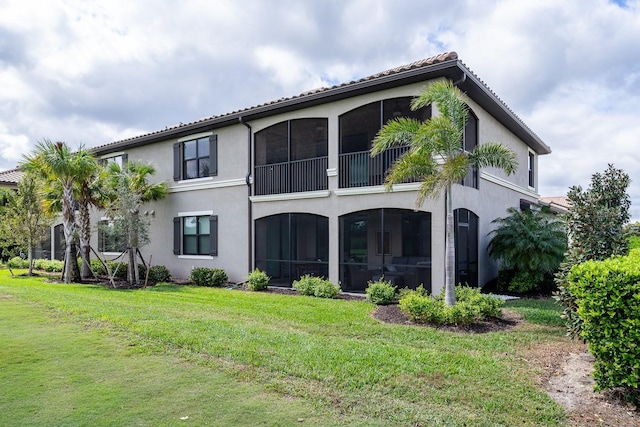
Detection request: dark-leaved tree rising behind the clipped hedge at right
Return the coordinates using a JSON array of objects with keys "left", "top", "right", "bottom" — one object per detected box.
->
[{"left": 555, "top": 164, "right": 631, "bottom": 337}]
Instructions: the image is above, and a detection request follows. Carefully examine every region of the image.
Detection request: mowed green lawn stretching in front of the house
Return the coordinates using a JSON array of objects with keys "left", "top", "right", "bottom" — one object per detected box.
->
[{"left": 0, "top": 271, "right": 566, "bottom": 426}]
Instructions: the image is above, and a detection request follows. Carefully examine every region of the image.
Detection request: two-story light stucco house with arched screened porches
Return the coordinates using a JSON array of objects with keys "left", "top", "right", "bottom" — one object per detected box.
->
[{"left": 40, "top": 52, "right": 550, "bottom": 293}]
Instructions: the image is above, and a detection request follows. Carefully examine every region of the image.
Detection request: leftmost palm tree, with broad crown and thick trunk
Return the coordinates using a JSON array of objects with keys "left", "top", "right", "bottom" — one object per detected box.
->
[{"left": 21, "top": 140, "right": 90, "bottom": 283}]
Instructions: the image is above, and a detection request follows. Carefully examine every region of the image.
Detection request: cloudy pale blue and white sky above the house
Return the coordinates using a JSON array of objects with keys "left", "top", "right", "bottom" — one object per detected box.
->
[{"left": 0, "top": 0, "right": 640, "bottom": 220}]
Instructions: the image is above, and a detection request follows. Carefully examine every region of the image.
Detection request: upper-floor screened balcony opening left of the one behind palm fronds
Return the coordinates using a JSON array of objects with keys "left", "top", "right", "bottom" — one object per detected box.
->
[{"left": 254, "top": 118, "right": 328, "bottom": 195}]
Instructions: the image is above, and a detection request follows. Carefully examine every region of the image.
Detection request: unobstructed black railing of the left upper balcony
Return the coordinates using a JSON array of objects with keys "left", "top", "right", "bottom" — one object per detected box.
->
[{"left": 254, "top": 156, "right": 329, "bottom": 196}]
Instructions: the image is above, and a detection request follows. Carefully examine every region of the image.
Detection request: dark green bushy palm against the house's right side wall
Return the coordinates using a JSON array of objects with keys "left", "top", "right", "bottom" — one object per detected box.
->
[{"left": 487, "top": 208, "right": 567, "bottom": 293}]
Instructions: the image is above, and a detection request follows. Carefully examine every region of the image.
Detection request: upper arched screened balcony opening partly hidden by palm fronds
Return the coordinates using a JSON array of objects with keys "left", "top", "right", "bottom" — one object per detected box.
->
[{"left": 339, "top": 96, "right": 431, "bottom": 188}]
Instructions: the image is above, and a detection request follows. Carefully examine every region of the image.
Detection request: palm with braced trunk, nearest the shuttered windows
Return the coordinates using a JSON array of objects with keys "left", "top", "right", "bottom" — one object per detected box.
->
[{"left": 106, "top": 162, "right": 167, "bottom": 285}]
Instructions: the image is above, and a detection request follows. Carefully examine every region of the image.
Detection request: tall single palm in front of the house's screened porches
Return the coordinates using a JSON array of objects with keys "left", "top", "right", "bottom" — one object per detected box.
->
[{"left": 371, "top": 81, "right": 518, "bottom": 305}]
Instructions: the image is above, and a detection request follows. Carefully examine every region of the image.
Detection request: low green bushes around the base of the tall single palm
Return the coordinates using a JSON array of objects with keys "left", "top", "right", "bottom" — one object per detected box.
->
[{"left": 400, "top": 286, "right": 504, "bottom": 325}]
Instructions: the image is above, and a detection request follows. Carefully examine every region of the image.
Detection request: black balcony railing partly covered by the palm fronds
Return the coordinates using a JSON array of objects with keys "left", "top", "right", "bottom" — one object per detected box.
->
[{"left": 339, "top": 146, "right": 409, "bottom": 188}]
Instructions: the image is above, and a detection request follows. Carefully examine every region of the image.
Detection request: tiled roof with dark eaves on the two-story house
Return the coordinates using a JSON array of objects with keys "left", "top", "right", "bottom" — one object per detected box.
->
[{"left": 92, "top": 52, "right": 551, "bottom": 155}]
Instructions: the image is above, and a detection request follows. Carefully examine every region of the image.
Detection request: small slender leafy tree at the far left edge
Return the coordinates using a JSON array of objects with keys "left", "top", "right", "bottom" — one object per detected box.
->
[{"left": 0, "top": 174, "right": 53, "bottom": 276}]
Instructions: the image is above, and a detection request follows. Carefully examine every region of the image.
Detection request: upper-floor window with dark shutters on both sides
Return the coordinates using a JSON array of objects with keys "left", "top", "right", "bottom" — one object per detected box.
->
[{"left": 173, "top": 134, "right": 218, "bottom": 181}]
